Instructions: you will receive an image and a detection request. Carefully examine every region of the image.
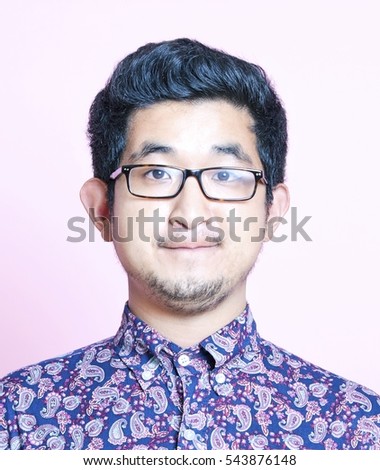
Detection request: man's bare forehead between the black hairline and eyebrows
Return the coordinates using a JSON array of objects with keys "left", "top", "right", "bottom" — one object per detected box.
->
[{"left": 123, "top": 100, "right": 257, "bottom": 163}]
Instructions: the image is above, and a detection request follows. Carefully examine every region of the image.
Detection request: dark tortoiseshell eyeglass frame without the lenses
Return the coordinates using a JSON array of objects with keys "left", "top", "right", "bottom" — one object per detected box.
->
[{"left": 110, "top": 164, "right": 268, "bottom": 201}]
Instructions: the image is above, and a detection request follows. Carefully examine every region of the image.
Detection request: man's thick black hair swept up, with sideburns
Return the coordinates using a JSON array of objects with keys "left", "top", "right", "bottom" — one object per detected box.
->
[{"left": 88, "top": 38, "right": 287, "bottom": 208}]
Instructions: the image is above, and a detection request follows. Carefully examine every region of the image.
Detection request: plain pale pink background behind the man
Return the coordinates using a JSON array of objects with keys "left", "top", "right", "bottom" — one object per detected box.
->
[{"left": 0, "top": 0, "right": 380, "bottom": 392}]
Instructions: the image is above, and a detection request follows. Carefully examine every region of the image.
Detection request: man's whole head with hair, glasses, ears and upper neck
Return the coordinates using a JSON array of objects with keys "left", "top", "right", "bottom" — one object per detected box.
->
[{"left": 81, "top": 39, "right": 288, "bottom": 314}]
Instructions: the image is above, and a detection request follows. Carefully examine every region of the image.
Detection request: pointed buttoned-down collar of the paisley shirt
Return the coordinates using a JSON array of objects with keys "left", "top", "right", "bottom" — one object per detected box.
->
[{"left": 114, "top": 303, "right": 258, "bottom": 390}]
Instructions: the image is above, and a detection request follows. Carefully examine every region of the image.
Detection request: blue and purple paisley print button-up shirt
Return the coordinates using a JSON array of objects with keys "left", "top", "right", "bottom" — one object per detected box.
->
[{"left": 0, "top": 305, "right": 380, "bottom": 450}]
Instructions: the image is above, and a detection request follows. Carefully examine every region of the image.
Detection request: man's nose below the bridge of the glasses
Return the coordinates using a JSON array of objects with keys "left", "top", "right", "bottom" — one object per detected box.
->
[{"left": 170, "top": 176, "right": 212, "bottom": 230}]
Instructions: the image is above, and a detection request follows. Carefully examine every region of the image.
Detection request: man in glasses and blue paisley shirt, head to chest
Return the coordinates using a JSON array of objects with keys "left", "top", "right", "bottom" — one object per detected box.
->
[{"left": 0, "top": 39, "right": 380, "bottom": 450}]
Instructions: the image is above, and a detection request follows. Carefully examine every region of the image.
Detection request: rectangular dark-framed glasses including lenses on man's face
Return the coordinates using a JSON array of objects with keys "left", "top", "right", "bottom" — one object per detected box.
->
[{"left": 110, "top": 165, "right": 267, "bottom": 201}]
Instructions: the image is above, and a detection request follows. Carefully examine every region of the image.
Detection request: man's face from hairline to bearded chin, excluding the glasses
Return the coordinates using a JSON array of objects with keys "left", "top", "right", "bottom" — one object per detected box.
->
[{"left": 113, "top": 100, "right": 266, "bottom": 313}]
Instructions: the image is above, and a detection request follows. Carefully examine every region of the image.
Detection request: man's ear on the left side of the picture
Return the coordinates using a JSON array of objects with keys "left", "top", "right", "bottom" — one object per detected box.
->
[{"left": 80, "top": 178, "right": 112, "bottom": 242}]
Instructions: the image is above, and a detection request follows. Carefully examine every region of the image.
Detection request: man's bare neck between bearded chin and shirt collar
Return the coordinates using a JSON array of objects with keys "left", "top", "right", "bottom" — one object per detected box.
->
[{"left": 128, "top": 281, "right": 246, "bottom": 348}]
